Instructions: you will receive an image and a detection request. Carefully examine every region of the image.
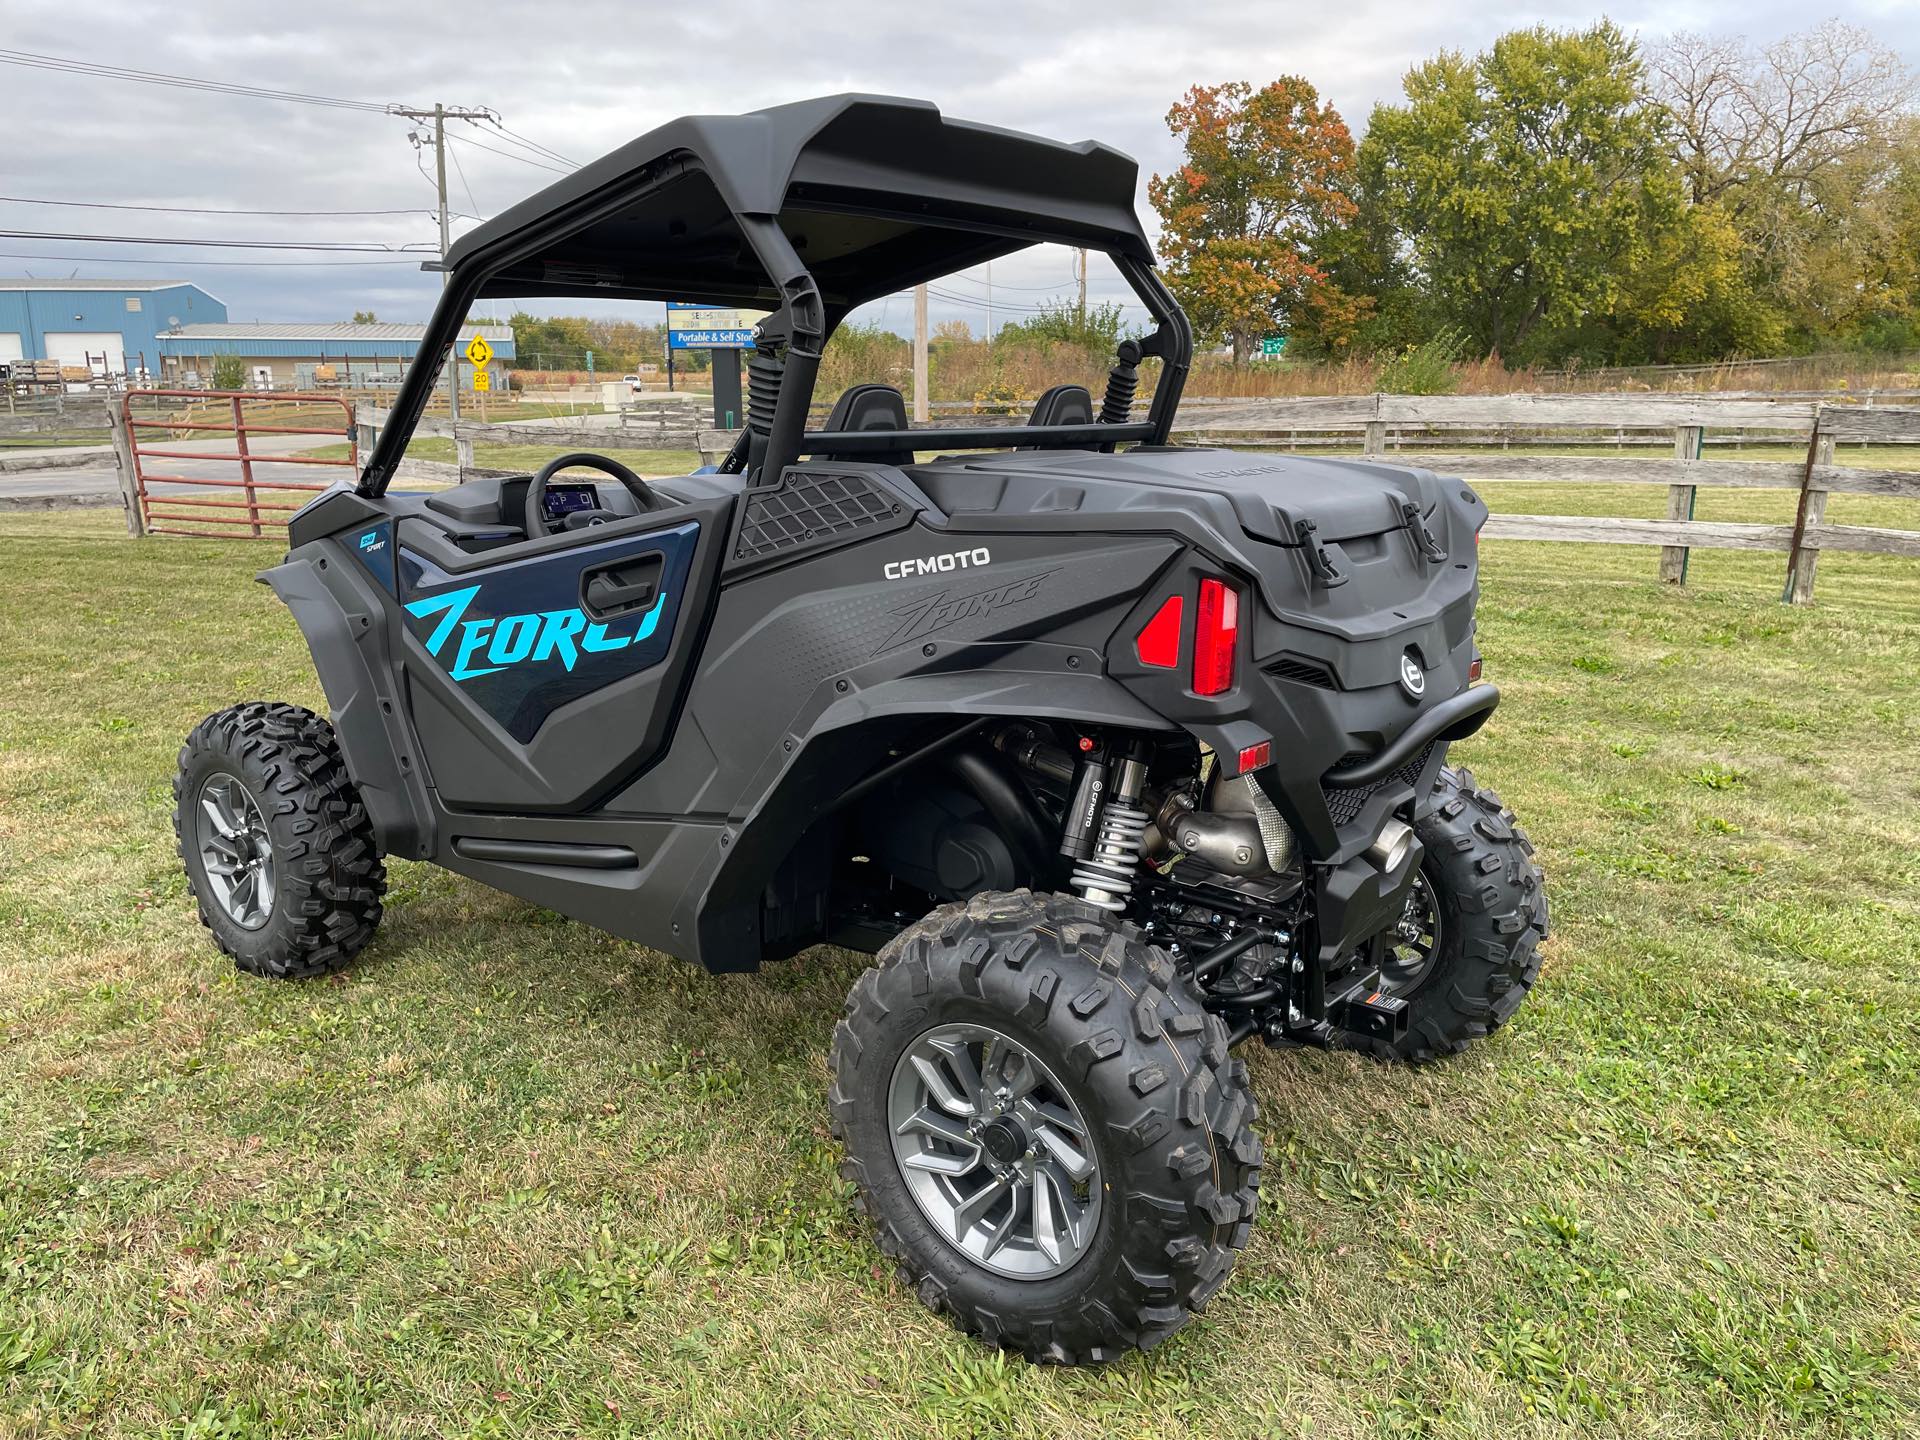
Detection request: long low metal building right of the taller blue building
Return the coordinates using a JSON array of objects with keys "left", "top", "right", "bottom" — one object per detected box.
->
[{"left": 156, "top": 321, "right": 513, "bottom": 390}]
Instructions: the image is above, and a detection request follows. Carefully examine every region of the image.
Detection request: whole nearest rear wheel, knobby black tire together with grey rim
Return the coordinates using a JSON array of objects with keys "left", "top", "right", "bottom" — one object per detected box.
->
[{"left": 831, "top": 891, "right": 1261, "bottom": 1363}]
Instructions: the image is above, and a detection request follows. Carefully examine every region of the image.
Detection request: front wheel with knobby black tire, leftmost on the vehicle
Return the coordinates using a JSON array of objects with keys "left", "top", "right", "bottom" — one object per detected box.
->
[{"left": 173, "top": 701, "right": 386, "bottom": 979}]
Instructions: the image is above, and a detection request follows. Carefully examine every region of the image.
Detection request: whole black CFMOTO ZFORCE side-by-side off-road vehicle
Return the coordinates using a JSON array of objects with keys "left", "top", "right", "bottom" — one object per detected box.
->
[{"left": 175, "top": 96, "right": 1548, "bottom": 1361}]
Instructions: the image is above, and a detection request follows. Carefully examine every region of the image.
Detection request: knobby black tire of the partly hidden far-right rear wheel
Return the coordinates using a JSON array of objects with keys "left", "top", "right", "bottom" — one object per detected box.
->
[{"left": 1352, "top": 766, "right": 1548, "bottom": 1062}]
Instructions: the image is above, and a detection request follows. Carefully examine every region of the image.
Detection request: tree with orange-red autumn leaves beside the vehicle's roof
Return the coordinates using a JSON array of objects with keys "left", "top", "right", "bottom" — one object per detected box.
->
[{"left": 1146, "top": 75, "right": 1365, "bottom": 365}]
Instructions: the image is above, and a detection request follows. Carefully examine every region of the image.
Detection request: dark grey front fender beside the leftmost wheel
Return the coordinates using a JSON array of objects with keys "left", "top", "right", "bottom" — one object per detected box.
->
[{"left": 259, "top": 541, "right": 434, "bottom": 860}]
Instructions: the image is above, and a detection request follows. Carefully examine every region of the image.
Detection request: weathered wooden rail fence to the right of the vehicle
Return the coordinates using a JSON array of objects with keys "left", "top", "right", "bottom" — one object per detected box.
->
[{"left": 1175, "top": 394, "right": 1920, "bottom": 605}]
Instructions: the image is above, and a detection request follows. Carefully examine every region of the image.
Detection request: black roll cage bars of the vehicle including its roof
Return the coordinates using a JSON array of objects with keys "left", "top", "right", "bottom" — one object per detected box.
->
[{"left": 357, "top": 96, "right": 1192, "bottom": 495}]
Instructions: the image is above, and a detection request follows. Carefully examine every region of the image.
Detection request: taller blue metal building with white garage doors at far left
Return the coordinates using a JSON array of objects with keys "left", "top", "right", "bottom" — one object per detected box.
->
[{"left": 0, "top": 278, "right": 227, "bottom": 378}]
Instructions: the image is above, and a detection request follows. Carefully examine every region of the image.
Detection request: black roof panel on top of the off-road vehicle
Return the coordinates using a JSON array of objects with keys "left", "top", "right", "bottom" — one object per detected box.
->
[{"left": 447, "top": 94, "right": 1152, "bottom": 313}]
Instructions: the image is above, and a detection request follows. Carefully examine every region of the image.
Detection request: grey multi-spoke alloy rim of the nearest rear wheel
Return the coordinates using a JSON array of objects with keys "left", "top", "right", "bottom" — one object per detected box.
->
[{"left": 887, "top": 1025, "right": 1100, "bottom": 1281}]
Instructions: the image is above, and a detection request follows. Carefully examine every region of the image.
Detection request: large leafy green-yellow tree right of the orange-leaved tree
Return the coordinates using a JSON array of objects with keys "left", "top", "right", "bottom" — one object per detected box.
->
[{"left": 1361, "top": 21, "right": 1684, "bottom": 359}]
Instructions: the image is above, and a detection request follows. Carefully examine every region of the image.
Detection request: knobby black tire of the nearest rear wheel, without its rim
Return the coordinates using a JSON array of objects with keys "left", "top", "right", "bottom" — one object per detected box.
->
[{"left": 831, "top": 891, "right": 1261, "bottom": 1363}]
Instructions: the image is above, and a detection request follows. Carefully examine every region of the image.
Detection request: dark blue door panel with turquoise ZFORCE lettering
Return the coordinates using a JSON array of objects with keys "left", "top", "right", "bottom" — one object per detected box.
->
[{"left": 399, "top": 522, "right": 699, "bottom": 743}]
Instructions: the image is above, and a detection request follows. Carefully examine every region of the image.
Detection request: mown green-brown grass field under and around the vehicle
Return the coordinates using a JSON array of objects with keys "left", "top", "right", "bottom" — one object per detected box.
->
[{"left": 0, "top": 499, "right": 1920, "bottom": 1440}]
